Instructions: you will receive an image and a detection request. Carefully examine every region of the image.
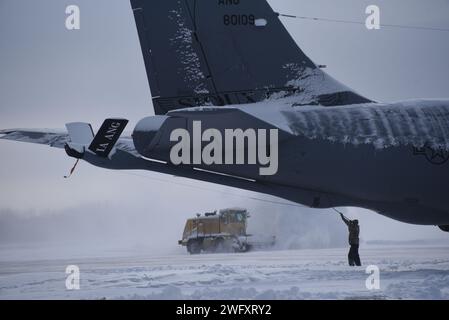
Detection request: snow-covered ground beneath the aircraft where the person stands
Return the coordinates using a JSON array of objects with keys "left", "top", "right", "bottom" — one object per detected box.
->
[{"left": 0, "top": 245, "right": 449, "bottom": 299}]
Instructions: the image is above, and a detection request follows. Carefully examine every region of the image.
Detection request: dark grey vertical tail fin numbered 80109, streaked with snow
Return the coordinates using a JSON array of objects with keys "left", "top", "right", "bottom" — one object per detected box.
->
[{"left": 131, "top": 0, "right": 370, "bottom": 115}]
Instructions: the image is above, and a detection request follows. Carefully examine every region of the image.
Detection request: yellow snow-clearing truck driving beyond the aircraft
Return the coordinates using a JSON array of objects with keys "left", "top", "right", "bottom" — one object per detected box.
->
[{"left": 178, "top": 209, "right": 251, "bottom": 254}]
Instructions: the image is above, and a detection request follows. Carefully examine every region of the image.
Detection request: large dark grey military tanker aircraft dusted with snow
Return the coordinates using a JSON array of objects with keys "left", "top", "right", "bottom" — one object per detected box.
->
[{"left": 0, "top": 0, "right": 449, "bottom": 231}]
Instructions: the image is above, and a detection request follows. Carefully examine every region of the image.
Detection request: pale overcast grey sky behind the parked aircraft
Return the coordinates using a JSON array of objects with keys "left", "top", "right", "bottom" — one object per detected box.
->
[{"left": 0, "top": 0, "right": 449, "bottom": 248}]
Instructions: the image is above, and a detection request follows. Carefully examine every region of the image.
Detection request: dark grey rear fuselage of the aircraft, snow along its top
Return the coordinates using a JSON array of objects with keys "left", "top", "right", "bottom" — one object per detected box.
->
[{"left": 133, "top": 100, "right": 449, "bottom": 225}]
